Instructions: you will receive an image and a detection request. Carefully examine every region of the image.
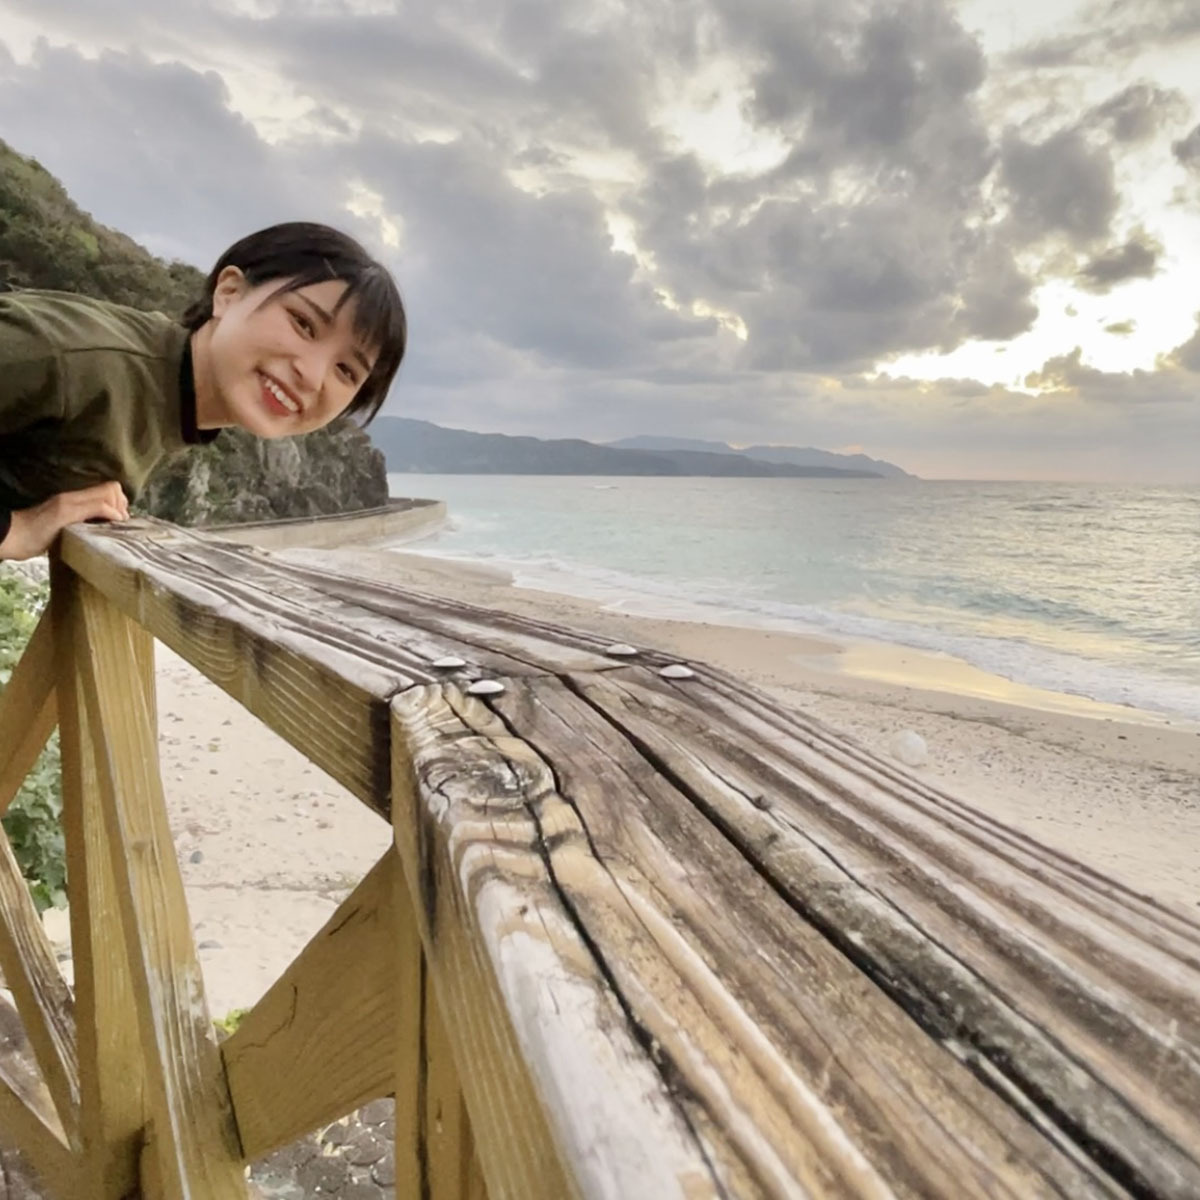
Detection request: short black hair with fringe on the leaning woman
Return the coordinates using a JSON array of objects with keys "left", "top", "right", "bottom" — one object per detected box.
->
[{"left": 184, "top": 221, "right": 408, "bottom": 425}]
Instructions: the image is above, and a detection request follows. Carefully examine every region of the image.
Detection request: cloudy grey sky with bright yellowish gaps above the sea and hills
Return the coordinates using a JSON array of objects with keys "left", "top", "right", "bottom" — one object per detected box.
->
[{"left": 0, "top": 0, "right": 1200, "bottom": 484}]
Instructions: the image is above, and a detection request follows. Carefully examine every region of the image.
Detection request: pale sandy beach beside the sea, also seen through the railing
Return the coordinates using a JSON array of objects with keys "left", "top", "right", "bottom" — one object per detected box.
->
[{"left": 140, "top": 550, "right": 1200, "bottom": 1015}]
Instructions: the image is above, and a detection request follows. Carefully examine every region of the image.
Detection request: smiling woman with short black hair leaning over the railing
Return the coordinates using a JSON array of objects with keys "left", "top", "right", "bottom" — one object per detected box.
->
[{"left": 0, "top": 222, "right": 408, "bottom": 559}]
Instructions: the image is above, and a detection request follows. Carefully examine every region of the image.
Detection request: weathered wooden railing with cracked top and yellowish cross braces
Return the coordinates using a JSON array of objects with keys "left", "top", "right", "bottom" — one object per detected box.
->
[{"left": 0, "top": 524, "right": 1200, "bottom": 1200}]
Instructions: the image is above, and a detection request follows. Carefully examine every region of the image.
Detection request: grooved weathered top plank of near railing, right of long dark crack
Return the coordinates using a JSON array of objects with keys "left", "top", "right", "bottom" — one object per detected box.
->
[{"left": 561, "top": 676, "right": 1200, "bottom": 1195}]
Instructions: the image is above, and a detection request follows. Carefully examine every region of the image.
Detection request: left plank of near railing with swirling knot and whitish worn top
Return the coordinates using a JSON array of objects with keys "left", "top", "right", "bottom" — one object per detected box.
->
[{"left": 392, "top": 686, "right": 720, "bottom": 1200}]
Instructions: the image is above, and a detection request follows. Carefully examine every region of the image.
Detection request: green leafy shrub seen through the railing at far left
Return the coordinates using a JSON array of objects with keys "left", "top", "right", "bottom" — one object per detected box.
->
[{"left": 0, "top": 570, "right": 67, "bottom": 912}]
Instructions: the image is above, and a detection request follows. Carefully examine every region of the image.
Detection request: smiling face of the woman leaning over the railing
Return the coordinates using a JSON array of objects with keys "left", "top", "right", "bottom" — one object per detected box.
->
[{"left": 197, "top": 268, "right": 374, "bottom": 438}]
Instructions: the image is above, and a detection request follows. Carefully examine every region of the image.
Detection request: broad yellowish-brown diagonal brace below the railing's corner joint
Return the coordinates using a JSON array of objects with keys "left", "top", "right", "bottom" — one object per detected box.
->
[{"left": 222, "top": 851, "right": 408, "bottom": 1160}]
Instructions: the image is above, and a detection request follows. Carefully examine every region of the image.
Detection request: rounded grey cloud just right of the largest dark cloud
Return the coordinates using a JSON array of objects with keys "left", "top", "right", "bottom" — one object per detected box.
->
[{"left": 1001, "top": 128, "right": 1120, "bottom": 247}]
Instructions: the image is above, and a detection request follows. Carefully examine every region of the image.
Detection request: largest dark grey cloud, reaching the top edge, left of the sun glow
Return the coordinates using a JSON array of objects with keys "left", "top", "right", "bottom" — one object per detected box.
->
[{"left": 629, "top": 0, "right": 1036, "bottom": 370}]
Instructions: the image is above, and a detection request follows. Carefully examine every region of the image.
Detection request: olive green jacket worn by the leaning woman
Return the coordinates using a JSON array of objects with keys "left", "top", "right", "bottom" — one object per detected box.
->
[{"left": 0, "top": 290, "right": 215, "bottom": 539}]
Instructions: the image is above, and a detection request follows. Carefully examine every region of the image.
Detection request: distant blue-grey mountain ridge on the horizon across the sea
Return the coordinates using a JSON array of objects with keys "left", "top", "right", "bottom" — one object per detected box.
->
[{"left": 370, "top": 416, "right": 899, "bottom": 479}]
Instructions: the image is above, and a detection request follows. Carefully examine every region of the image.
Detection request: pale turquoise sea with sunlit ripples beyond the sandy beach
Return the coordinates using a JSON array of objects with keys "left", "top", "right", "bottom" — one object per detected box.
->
[{"left": 390, "top": 475, "right": 1200, "bottom": 720}]
